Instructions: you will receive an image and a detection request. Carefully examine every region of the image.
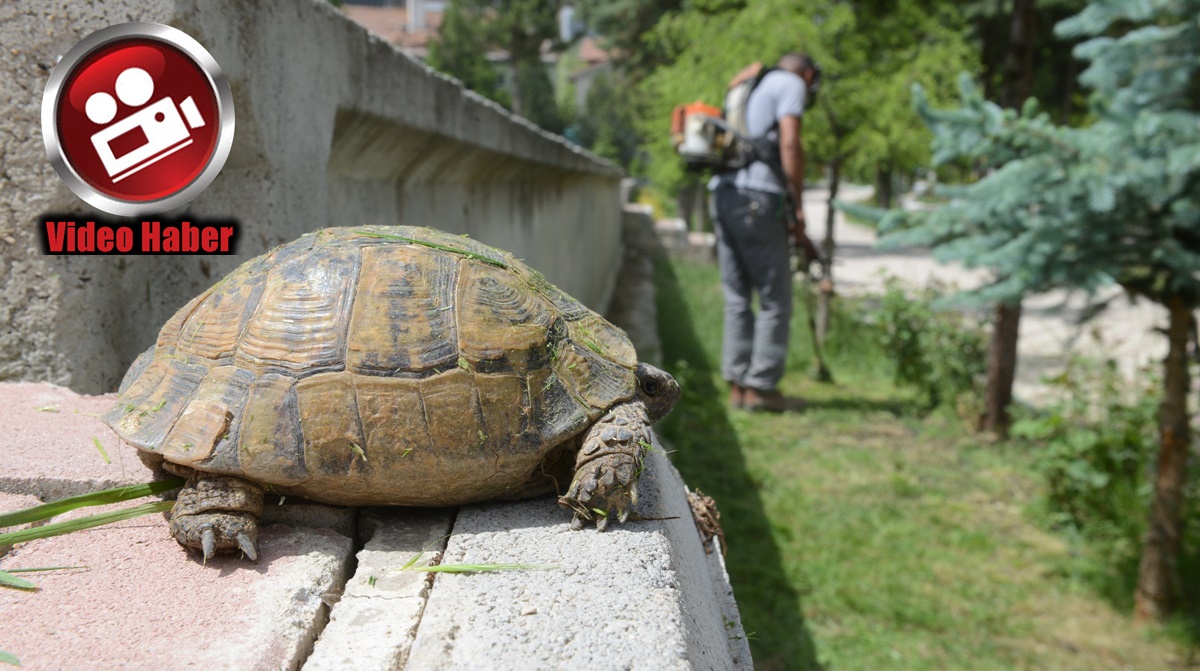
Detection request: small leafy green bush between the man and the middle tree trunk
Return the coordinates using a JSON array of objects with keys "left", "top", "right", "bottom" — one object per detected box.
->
[{"left": 875, "top": 278, "right": 986, "bottom": 408}]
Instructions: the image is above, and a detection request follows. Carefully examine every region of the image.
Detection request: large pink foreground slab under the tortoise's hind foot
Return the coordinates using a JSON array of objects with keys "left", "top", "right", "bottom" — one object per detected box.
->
[{"left": 0, "top": 507, "right": 352, "bottom": 670}]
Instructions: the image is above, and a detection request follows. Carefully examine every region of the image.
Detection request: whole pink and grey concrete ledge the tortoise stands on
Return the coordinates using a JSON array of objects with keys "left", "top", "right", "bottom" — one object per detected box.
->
[{"left": 0, "top": 383, "right": 751, "bottom": 670}]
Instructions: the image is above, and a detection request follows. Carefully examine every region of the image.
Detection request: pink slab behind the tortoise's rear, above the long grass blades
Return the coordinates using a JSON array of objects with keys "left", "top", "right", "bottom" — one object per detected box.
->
[{"left": 0, "top": 382, "right": 155, "bottom": 501}]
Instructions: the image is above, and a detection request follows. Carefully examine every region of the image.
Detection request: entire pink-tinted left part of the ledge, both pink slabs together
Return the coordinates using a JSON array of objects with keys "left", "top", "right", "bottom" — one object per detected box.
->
[{"left": 0, "top": 383, "right": 355, "bottom": 669}]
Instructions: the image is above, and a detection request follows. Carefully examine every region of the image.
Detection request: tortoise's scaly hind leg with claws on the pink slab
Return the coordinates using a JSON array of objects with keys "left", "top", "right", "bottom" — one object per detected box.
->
[{"left": 170, "top": 472, "right": 263, "bottom": 562}]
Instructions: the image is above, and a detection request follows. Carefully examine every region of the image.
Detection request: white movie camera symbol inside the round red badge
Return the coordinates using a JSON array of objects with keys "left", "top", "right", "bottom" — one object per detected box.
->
[{"left": 84, "top": 67, "right": 204, "bottom": 184}]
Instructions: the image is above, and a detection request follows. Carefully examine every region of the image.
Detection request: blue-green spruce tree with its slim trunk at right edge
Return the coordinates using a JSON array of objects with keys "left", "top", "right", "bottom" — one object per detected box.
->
[{"left": 859, "top": 0, "right": 1200, "bottom": 619}]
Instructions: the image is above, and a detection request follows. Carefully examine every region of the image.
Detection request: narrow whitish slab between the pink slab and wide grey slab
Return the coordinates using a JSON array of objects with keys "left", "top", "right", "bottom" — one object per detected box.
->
[{"left": 304, "top": 508, "right": 455, "bottom": 671}]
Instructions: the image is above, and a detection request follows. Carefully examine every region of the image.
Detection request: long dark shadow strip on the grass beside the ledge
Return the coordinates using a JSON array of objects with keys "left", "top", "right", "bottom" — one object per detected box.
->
[{"left": 655, "top": 259, "right": 822, "bottom": 671}]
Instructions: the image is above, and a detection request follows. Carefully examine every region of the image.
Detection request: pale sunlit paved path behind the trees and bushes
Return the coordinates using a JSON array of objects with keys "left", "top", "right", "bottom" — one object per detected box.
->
[{"left": 804, "top": 186, "right": 1166, "bottom": 400}]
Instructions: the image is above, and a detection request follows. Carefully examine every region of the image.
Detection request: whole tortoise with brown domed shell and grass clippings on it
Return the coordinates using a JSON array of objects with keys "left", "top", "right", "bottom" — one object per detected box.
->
[{"left": 103, "top": 227, "right": 680, "bottom": 561}]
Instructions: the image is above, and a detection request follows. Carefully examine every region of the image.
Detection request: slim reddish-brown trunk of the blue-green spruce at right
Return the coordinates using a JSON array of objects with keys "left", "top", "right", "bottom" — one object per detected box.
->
[{"left": 1134, "top": 296, "right": 1192, "bottom": 622}]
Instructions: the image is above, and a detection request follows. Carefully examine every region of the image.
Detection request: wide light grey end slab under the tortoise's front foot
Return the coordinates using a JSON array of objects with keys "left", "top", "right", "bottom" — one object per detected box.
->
[{"left": 408, "top": 441, "right": 750, "bottom": 670}]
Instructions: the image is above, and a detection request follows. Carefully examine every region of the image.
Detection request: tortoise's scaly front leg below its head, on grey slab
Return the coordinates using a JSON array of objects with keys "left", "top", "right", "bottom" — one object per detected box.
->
[{"left": 558, "top": 401, "right": 650, "bottom": 531}]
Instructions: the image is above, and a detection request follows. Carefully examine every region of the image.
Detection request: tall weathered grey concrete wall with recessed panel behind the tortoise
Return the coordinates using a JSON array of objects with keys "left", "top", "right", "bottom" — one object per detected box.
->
[{"left": 0, "top": 0, "right": 620, "bottom": 393}]
